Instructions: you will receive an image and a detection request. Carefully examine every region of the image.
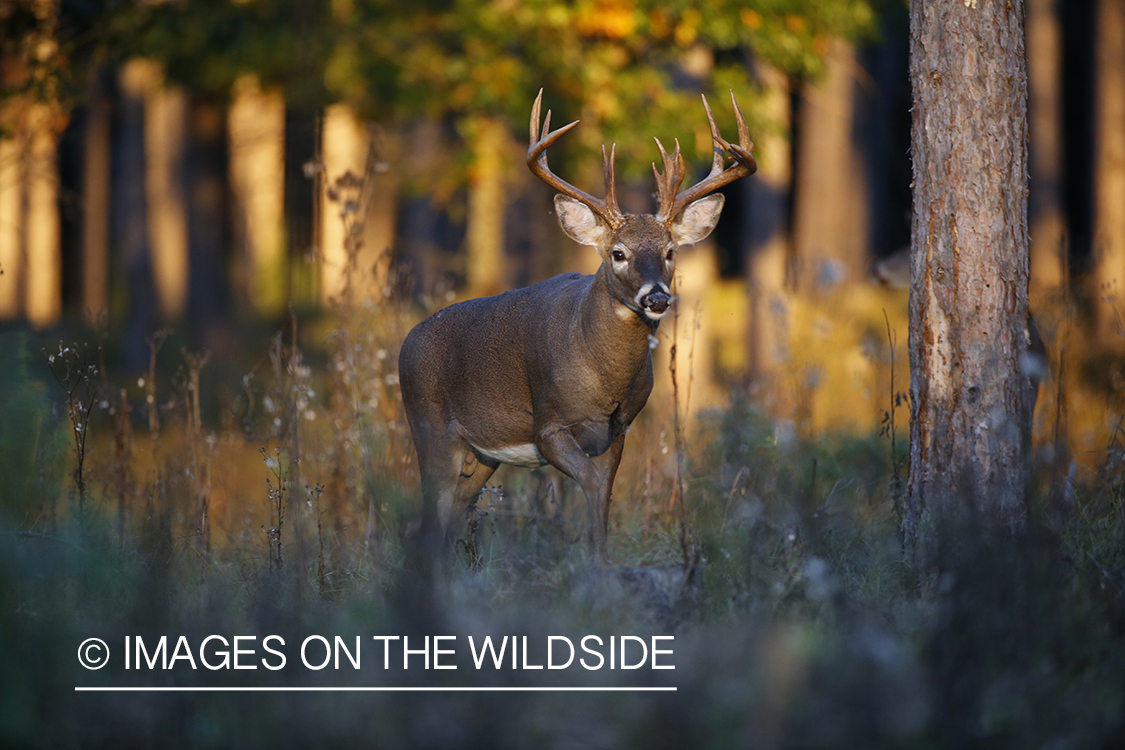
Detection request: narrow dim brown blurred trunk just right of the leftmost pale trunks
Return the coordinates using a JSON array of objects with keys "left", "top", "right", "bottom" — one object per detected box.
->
[{"left": 82, "top": 69, "right": 111, "bottom": 323}]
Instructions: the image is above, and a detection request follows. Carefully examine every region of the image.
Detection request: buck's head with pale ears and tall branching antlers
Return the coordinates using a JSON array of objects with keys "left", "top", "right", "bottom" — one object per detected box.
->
[{"left": 528, "top": 91, "right": 757, "bottom": 323}]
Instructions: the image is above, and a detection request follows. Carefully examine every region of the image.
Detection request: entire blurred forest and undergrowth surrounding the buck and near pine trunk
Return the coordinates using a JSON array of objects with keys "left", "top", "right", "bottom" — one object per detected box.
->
[{"left": 0, "top": 0, "right": 1125, "bottom": 749}]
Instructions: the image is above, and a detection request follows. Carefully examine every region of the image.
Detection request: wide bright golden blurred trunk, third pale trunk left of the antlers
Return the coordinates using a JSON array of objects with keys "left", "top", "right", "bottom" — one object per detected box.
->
[{"left": 227, "top": 75, "right": 288, "bottom": 317}]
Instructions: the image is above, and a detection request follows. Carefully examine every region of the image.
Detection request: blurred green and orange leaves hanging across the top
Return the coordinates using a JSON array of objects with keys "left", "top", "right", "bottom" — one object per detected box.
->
[{"left": 2, "top": 0, "right": 879, "bottom": 171}]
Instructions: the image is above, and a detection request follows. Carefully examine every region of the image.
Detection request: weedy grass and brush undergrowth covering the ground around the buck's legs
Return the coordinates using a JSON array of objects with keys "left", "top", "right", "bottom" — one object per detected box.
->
[{"left": 0, "top": 311, "right": 1125, "bottom": 748}]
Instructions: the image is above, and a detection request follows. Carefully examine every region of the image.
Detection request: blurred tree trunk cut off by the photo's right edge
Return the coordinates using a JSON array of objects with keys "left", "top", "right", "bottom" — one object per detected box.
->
[{"left": 1094, "top": 0, "right": 1125, "bottom": 349}]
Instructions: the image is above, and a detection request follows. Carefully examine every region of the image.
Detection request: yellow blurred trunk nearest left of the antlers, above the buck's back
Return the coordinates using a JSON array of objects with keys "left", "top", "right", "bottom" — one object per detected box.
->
[{"left": 465, "top": 117, "right": 511, "bottom": 297}]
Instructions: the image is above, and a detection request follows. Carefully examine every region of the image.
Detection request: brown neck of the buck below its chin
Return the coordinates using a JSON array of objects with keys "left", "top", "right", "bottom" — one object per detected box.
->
[{"left": 576, "top": 263, "right": 656, "bottom": 377}]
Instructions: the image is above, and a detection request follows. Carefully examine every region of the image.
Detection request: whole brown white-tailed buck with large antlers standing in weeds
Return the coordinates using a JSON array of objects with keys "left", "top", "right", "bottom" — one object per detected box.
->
[{"left": 398, "top": 91, "right": 757, "bottom": 562}]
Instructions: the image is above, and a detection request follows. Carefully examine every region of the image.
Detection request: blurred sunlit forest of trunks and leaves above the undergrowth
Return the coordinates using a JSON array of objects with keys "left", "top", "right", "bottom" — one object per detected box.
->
[{"left": 0, "top": 0, "right": 1125, "bottom": 440}]
